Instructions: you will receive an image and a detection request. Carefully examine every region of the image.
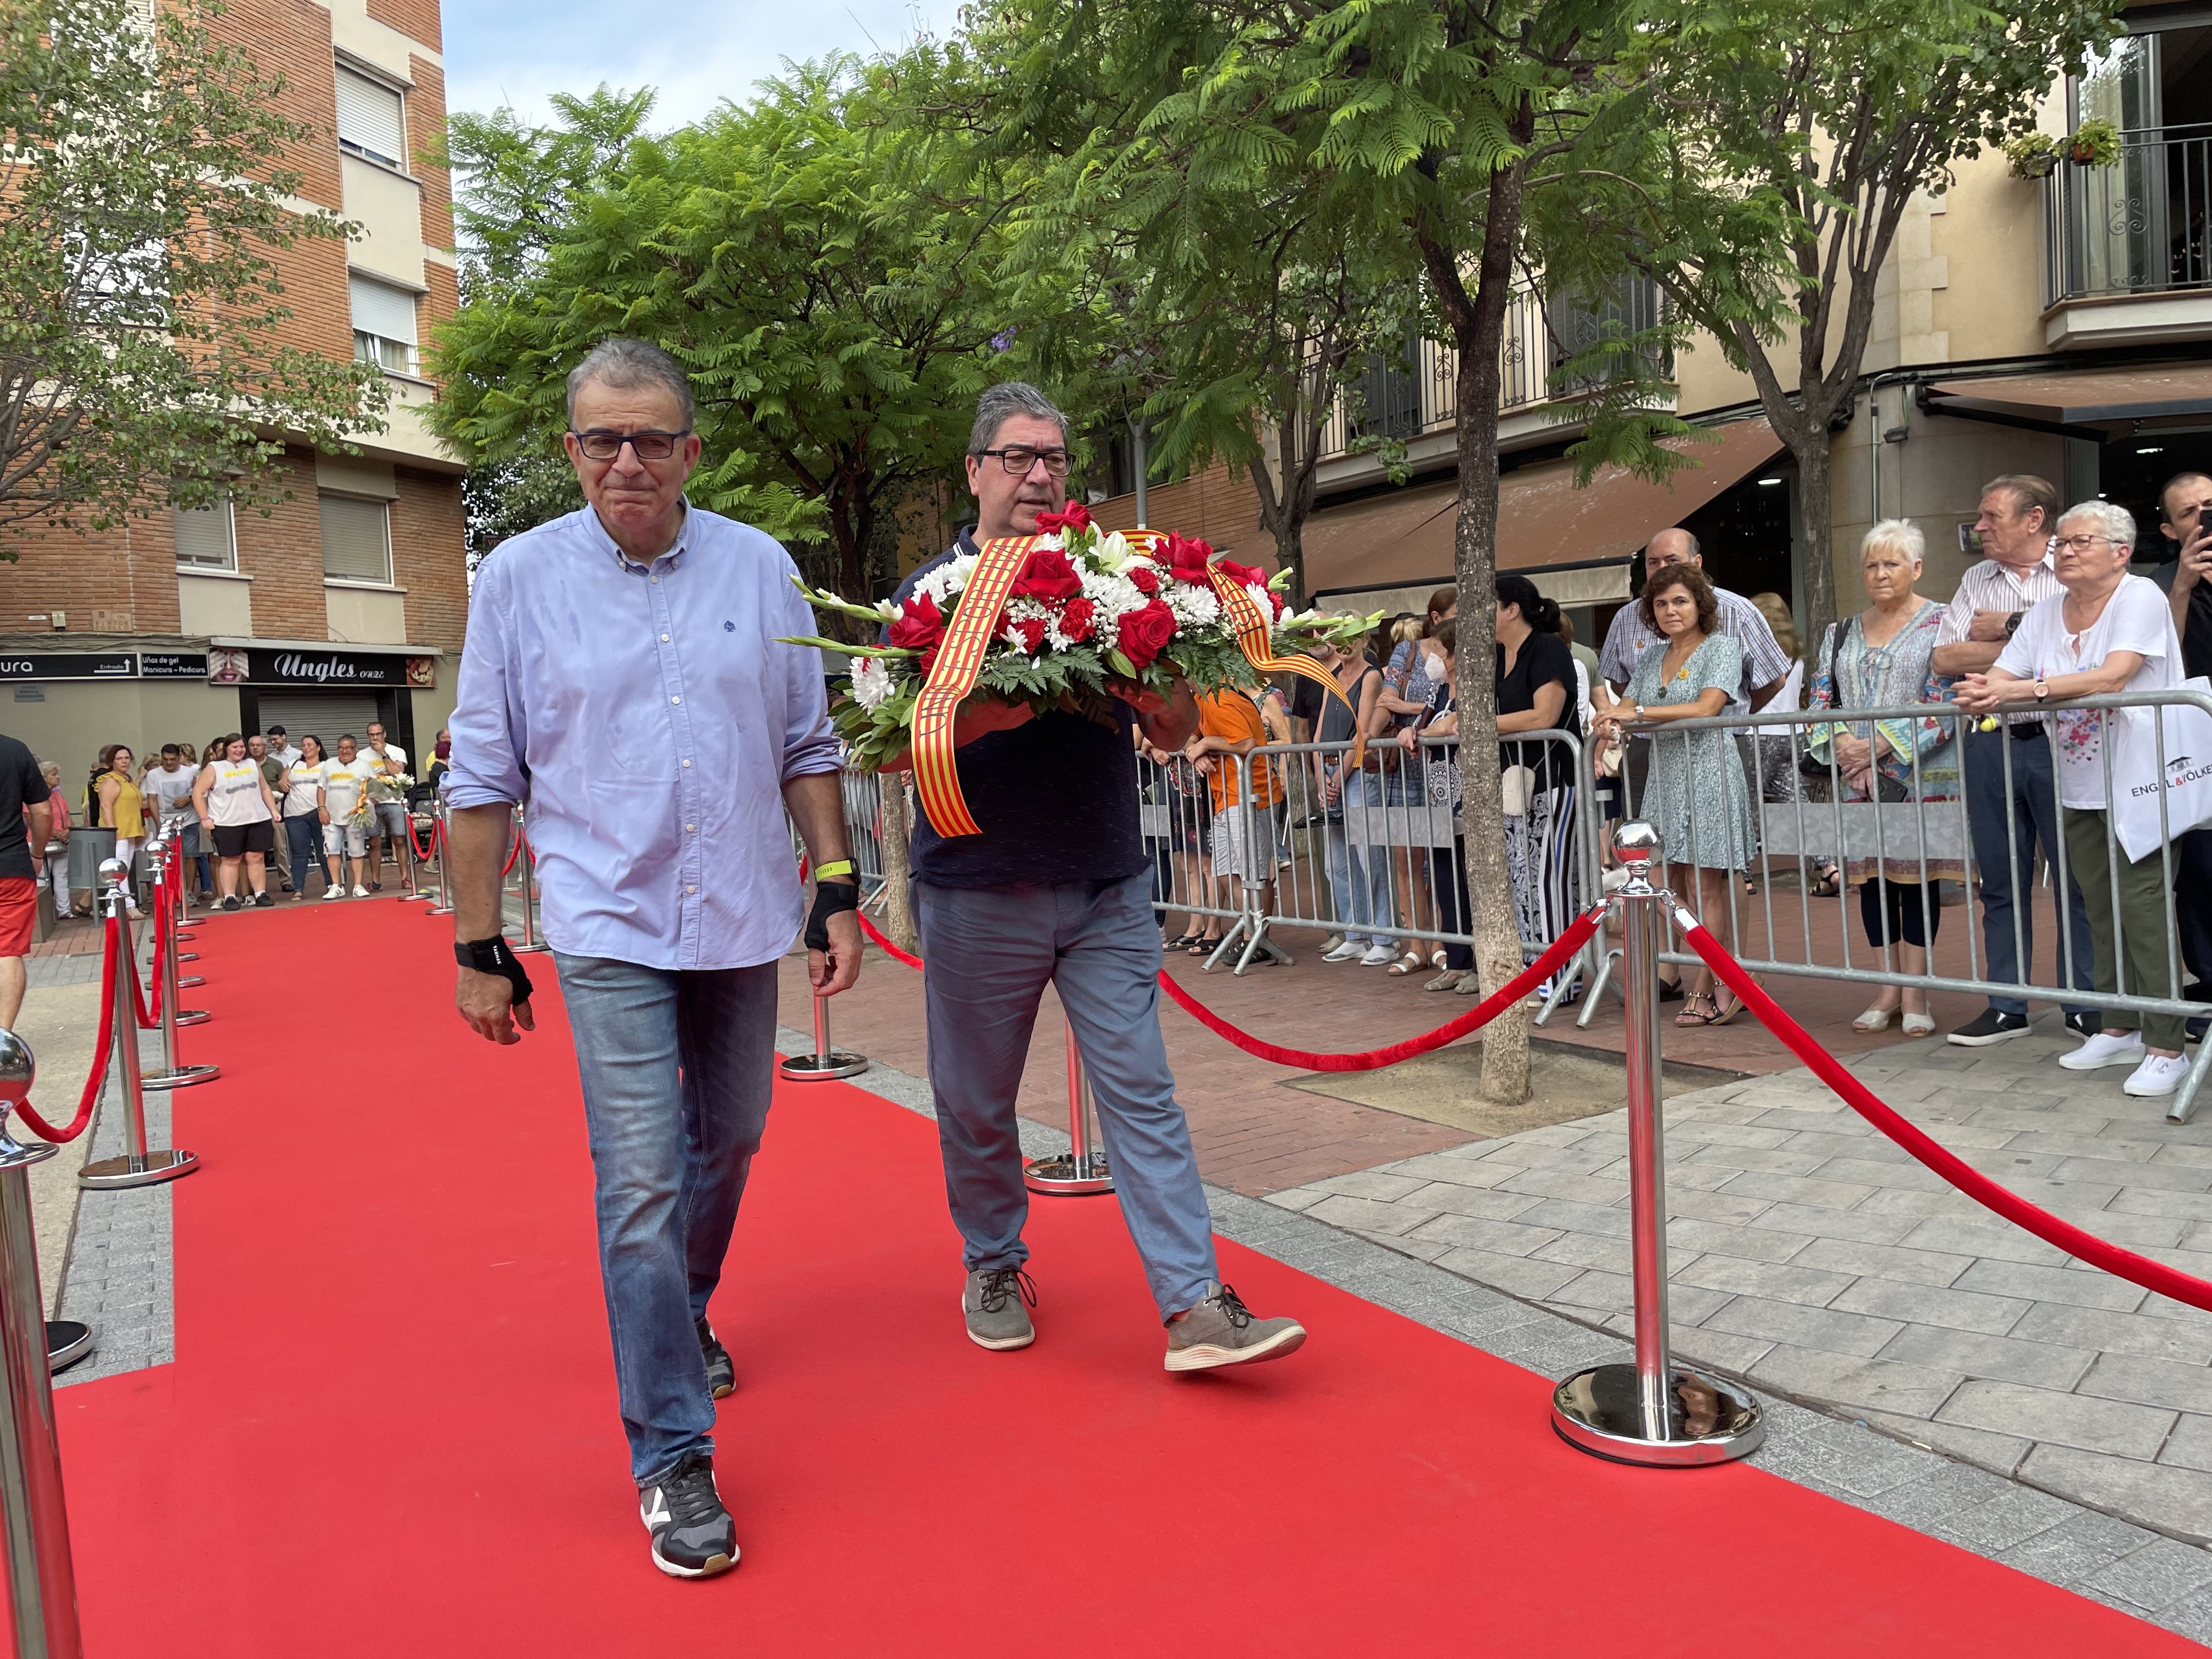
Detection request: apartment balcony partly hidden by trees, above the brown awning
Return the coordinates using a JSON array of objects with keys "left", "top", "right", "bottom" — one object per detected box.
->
[{"left": 1321, "top": 281, "right": 1659, "bottom": 489}]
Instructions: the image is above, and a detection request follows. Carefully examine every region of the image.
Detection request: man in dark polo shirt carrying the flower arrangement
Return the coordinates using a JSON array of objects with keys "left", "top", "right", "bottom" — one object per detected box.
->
[{"left": 898, "top": 383, "right": 1305, "bottom": 1372}]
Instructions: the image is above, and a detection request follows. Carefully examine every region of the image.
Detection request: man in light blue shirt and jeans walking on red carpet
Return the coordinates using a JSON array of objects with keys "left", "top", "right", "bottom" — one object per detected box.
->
[{"left": 444, "top": 341, "right": 860, "bottom": 1577}]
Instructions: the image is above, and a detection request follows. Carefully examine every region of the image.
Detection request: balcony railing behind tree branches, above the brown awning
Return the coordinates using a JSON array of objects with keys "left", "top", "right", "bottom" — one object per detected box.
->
[{"left": 1321, "top": 281, "right": 1659, "bottom": 460}]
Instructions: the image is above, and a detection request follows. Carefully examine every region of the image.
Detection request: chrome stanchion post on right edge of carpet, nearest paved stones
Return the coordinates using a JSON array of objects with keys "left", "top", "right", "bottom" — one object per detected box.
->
[{"left": 1550, "top": 823, "right": 1765, "bottom": 1464}]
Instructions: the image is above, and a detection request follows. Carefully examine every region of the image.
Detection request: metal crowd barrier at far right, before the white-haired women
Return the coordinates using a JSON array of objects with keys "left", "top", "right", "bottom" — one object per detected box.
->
[{"left": 1621, "top": 688, "right": 2212, "bottom": 1121}]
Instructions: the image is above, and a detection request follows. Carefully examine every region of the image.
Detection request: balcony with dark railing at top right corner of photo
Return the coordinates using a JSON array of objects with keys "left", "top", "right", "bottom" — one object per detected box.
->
[{"left": 2044, "top": 128, "right": 2212, "bottom": 349}]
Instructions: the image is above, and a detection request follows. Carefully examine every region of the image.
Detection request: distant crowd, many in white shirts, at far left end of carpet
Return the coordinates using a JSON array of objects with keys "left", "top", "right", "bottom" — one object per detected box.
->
[{"left": 31, "top": 721, "right": 452, "bottom": 916}]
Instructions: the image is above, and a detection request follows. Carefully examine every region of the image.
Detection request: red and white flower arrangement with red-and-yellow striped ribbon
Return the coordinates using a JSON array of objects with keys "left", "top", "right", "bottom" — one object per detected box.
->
[{"left": 787, "top": 502, "right": 1374, "bottom": 822}]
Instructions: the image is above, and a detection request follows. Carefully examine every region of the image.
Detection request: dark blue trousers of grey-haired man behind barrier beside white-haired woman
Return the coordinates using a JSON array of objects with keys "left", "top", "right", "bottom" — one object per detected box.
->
[{"left": 1966, "top": 725, "right": 2097, "bottom": 1013}]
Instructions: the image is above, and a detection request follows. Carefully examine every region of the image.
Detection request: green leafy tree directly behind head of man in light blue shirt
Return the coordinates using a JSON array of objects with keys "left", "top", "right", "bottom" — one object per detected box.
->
[{"left": 433, "top": 58, "right": 1009, "bottom": 619}]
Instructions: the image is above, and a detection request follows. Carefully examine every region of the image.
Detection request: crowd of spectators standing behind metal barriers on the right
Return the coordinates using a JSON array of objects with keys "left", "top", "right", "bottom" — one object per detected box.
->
[{"left": 1139, "top": 473, "right": 2212, "bottom": 1097}]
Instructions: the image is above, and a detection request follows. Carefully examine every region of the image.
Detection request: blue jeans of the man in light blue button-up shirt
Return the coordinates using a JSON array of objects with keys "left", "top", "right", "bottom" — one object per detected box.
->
[{"left": 553, "top": 951, "right": 776, "bottom": 1484}]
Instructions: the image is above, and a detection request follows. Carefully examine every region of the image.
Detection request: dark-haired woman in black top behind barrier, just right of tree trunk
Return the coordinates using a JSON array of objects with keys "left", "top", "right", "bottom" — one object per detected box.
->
[{"left": 1496, "top": 575, "right": 1582, "bottom": 1005}]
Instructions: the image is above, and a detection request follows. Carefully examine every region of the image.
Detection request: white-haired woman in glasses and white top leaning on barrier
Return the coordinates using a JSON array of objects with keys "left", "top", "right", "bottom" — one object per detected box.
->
[{"left": 1955, "top": 500, "right": 2190, "bottom": 1099}]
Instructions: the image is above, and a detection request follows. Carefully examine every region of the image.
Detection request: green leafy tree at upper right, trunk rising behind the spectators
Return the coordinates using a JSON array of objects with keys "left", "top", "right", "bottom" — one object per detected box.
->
[{"left": 1560, "top": 0, "right": 2119, "bottom": 637}]
